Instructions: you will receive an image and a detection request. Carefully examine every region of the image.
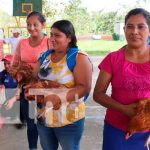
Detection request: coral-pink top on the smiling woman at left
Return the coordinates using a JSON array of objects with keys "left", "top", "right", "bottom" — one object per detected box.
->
[{"left": 14, "top": 36, "right": 48, "bottom": 68}]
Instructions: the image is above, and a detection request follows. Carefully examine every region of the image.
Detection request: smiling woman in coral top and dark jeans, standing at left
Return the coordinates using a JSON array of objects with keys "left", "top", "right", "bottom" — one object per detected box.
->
[{"left": 10, "top": 12, "right": 49, "bottom": 150}]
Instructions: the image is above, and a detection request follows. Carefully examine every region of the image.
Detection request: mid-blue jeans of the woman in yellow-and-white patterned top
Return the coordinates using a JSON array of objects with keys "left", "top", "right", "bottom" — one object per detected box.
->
[{"left": 37, "top": 119, "right": 85, "bottom": 150}]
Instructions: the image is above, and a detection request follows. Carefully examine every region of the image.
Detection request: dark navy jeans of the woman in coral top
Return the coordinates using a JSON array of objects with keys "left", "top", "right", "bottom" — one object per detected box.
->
[{"left": 20, "top": 93, "right": 38, "bottom": 149}]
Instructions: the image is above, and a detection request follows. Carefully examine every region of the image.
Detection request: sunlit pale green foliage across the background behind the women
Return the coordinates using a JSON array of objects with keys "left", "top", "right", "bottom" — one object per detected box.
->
[{"left": 0, "top": 0, "right": 145, "bottom": 36}]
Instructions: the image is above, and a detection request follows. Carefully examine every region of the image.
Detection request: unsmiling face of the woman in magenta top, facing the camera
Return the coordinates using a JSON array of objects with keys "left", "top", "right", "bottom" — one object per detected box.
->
[{"left": 124, "top": 14, "right": 150, "bottom": 48}]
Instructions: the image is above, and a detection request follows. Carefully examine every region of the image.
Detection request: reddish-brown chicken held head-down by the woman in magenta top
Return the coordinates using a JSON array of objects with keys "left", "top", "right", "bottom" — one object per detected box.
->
[{"left": 125, "top": 98, "right": 150, "bottom": 139}]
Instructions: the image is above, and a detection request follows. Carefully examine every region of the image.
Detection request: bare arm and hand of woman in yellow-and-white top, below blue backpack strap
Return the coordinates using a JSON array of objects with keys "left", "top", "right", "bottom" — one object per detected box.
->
[{"left": 44, "top": 54, "right": 92, "bottom": 109}]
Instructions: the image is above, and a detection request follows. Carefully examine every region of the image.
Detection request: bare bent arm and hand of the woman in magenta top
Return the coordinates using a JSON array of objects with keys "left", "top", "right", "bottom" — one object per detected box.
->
[{"left": 93, "top": 70, "right": 136, "bottom": 116}]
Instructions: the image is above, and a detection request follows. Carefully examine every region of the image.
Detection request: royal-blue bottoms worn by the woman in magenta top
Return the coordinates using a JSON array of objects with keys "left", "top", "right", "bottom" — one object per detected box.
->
[{"left": 102, "top": 121, "right": 150, "bottom": 150}]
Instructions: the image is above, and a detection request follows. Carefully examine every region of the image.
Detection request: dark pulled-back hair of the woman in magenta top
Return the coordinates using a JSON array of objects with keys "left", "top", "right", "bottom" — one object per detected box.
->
[{"left": 125, "top": 8, "right": 150, "bottom": 29}]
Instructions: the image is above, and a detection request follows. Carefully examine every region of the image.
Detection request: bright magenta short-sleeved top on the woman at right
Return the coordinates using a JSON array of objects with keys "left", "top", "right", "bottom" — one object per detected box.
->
[{"left": 99, "top": 48, "right": 150, "bottom": 131}]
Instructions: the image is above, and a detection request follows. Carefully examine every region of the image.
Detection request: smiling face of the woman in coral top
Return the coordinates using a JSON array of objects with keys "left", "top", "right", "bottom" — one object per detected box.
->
[{"left": 27, "top": 16, "right": 45, "bottom": 37}]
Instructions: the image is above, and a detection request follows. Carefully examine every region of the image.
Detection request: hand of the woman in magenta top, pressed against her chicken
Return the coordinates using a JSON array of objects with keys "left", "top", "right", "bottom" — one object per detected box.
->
[{"left": 122, "top": 103, "right": 137, "bottom": 118}]
